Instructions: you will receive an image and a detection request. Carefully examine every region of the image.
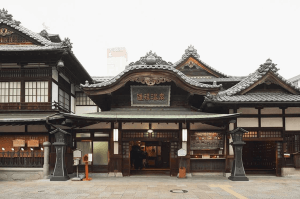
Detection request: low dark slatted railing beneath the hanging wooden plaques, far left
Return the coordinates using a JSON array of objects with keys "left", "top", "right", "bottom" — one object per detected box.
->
[{"left": 0, "top": 151, "right": 44, "bottom": 168}]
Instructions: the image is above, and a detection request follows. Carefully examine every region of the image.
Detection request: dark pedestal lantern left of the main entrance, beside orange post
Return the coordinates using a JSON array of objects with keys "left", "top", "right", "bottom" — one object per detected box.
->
[{"left": 50, "top": 128, "right": 70, "bottom": 181}]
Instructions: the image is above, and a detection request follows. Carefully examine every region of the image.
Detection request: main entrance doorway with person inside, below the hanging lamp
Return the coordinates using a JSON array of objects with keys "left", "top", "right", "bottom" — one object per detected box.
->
[{"left": 129, "top": 141, "right": 170, "bottom": 175}]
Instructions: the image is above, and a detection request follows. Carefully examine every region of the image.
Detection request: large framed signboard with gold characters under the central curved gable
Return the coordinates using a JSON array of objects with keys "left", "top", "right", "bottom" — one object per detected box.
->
[{"left": 131, "top": 86, "right": 171, "bottom": 107}]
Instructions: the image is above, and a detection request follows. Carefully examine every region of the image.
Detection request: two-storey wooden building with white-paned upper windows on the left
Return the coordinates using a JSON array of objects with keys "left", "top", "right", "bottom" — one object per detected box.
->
[{"left": 0, "top": 9, "right": 93, "bottom": 178}]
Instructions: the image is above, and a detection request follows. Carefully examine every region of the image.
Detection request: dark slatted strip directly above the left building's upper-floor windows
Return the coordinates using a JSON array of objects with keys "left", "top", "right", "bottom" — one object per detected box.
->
[{"left": 0, "top": 68, "right": 52, "bottom": 77}]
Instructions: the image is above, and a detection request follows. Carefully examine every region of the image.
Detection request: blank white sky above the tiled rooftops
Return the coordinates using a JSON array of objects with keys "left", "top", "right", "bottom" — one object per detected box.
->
[{"left": 0, "top": 0, "right": 300, "bottom": 79}]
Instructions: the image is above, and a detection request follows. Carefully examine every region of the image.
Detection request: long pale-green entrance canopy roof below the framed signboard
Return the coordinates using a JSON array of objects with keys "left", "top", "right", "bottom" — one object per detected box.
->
[{"left": 63, "top": 108, "right": 239, "bottom": 126}]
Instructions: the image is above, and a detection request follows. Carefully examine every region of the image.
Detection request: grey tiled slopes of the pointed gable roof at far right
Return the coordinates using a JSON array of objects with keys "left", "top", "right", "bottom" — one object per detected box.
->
[{"left": 218, "top": 59, "right": 300, "bottom": 96}]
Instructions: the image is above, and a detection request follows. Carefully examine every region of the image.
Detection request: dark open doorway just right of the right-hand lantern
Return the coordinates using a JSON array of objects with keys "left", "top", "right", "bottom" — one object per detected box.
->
[{"left": 243, "top": 141, "right": 276, "bottom": 175}]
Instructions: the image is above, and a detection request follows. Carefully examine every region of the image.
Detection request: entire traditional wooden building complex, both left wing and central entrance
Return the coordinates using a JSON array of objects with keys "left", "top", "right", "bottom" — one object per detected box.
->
[{"left": 0, "top": 10, "right": 300, "bottom": 180}]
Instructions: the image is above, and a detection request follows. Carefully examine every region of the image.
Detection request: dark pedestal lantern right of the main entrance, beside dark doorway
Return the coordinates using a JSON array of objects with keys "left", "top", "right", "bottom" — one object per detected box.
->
[{"left": 228, "top": 128, "right": 249, "bottom": 181}]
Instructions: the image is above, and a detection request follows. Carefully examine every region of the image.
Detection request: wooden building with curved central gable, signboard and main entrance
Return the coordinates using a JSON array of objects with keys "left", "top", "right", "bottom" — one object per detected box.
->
[{"left": 64, "top": 46, "right": 300, "bottom": 176}]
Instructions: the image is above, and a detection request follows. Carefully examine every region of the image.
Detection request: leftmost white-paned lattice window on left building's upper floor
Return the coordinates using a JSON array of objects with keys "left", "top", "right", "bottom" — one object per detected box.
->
[{"left": 0, "top": 82, "right": 21, "bottom": 103}]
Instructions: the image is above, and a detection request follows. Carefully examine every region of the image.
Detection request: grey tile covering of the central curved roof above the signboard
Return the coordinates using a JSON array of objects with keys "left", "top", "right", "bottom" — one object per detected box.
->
[{"left": 81, "top": 51, "right": 222, "bottom": 88}]
